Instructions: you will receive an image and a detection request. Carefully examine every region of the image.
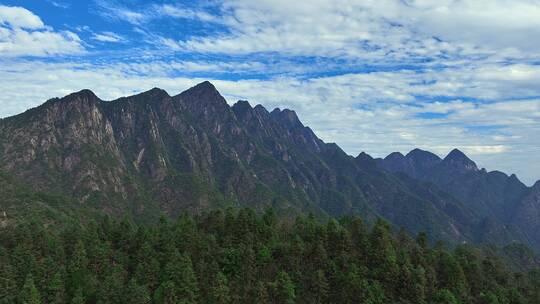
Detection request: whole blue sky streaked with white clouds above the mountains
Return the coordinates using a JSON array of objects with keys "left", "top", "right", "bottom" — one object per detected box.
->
[{"left": 0, "top": 0, "right": 540, "bottom": 185}]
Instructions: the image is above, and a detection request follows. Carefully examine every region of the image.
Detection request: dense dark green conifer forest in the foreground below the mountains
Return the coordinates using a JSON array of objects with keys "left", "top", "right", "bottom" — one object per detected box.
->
[{"left": 0, "top": 209, "right": 540, "bottom": 304}]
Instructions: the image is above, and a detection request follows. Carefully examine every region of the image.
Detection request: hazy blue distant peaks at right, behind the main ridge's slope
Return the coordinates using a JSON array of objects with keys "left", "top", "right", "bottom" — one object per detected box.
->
[{"left": 375, "top": 149, "right": 540, "bottom": 248}]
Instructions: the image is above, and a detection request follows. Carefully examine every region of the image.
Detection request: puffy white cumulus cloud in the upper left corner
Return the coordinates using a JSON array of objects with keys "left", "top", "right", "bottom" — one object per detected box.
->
[{"left": 0, "top": 5, "right": 84, "bottom": 57}]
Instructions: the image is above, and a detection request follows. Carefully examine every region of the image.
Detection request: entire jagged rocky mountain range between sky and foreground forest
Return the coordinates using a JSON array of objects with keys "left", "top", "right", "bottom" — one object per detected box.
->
[{"left": 0, "top": 82, "right": 540, "bottom": 246}]
